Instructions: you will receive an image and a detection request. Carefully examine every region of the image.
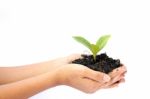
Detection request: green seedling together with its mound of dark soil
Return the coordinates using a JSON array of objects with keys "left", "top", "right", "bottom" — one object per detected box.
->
[{"left": 72, "top": 35, "right": 122, "bottom": 74}]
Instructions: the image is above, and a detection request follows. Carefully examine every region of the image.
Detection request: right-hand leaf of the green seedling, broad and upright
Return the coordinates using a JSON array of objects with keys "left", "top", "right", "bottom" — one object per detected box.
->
[{"left": 96, "top": 35, "right": 111, "bottom": 51}]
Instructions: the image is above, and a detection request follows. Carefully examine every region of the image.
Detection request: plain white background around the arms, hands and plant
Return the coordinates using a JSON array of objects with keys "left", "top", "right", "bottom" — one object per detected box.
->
[{"left": 0, "top": 0, "right": 150, "bottom": 99}]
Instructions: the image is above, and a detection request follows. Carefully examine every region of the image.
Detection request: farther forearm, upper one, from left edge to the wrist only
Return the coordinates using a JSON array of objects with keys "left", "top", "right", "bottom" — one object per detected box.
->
[{"left": 0, "top": 60, "right": 60, "bottom": 84}]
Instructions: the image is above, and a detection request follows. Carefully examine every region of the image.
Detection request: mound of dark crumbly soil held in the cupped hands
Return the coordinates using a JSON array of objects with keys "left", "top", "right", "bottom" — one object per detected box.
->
[{"left": 72, "top": 53, "right": 122, "bottom": 74}]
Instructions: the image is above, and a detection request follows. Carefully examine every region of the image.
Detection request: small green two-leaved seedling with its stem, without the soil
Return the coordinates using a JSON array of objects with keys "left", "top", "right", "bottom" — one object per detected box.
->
[{"left": 73, "top": 35, "right": 111, "bottom": 60}]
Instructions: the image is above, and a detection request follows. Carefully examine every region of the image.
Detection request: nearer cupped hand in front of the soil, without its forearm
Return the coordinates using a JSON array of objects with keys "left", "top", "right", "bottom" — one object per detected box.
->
[{"left": 57, "top": 64, "right": 110, "bottom": 93}]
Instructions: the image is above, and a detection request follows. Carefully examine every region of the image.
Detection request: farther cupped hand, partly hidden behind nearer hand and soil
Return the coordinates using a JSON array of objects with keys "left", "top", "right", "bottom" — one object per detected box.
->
[{"left": 53, "top": 54, "right": 127, "bottom": 88}]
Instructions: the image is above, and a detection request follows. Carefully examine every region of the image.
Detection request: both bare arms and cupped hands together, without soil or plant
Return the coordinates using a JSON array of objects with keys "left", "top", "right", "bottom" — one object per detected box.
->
[{"left": 0, "top": 54, "right": 126, "bottom": 99}]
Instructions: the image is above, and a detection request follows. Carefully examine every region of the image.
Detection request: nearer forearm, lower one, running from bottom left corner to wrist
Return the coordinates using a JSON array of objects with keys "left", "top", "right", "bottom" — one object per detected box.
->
[{"left": 0, "top": 71, "right": 58, "bottom": 99}]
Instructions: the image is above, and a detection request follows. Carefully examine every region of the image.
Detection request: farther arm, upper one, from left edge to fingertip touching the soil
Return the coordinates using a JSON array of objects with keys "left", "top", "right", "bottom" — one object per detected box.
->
[{"left": 0, "top": 54, "right": 81, "bottom": 85}]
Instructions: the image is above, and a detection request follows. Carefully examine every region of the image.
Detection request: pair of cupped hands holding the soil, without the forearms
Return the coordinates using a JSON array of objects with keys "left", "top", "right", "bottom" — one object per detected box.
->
[{"left": 53, "top": 54, "right": 127, "bottom": 93}]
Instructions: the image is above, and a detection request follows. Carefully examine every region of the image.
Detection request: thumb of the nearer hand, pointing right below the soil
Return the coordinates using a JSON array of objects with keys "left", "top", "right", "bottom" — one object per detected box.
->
[{"left": 84, "top": 68, "right": 110, "bottom": 83}]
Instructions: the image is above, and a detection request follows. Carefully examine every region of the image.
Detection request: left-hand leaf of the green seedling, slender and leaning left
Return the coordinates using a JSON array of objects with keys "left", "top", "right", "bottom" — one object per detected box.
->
[{"left": 73, "top": 36, "right": 92, "bottom": 50}]
